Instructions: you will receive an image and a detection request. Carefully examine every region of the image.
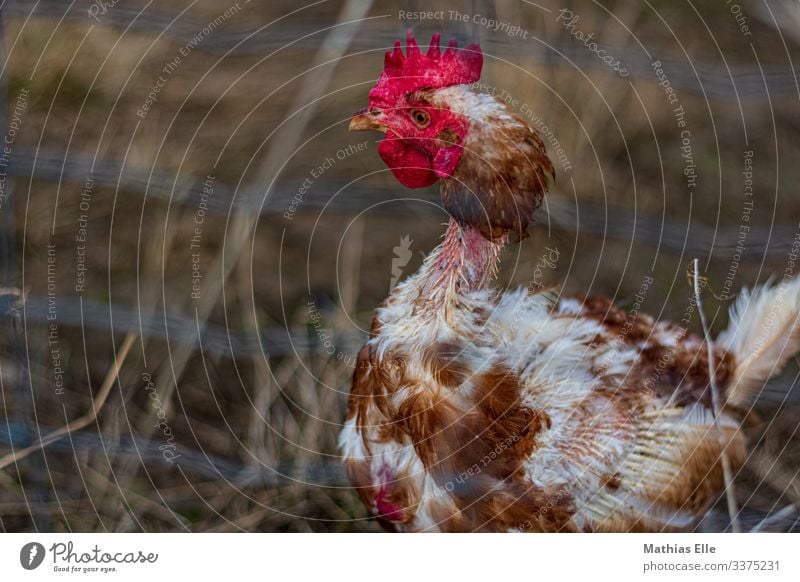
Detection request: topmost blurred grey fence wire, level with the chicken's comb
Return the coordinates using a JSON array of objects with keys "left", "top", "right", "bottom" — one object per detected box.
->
[{"left": 3, "top": 0, "right": 800, "bottom": 101}]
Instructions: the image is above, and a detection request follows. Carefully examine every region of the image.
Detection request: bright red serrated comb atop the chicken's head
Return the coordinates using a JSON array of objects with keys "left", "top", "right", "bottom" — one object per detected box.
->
[{"left": 369, "top": 30, "right": 483, "bottom": 107}]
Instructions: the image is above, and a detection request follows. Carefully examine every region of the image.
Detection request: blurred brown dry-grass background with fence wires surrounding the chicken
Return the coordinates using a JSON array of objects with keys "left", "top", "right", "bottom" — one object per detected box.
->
[{"left": 0, "top": 0, "right": 800, "bottom": 532}]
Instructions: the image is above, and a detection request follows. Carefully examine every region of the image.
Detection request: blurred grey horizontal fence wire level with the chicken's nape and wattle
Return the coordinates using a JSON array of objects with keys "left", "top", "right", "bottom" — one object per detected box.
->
[{"left": 10, "top": 150, "right": 797, "bottom": 262}]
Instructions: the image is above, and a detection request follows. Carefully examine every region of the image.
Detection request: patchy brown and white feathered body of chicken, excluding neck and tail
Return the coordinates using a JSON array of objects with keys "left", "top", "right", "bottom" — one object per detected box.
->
[{"left": 340, "top": 290, "right": 744, "bottom": 531}]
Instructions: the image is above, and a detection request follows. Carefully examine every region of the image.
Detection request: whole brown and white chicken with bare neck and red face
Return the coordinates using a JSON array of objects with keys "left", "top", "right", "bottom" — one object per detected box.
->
[{"left": 339, "top": 32, "right": 800, "bottom": 532}]
